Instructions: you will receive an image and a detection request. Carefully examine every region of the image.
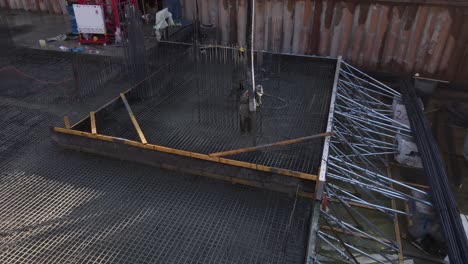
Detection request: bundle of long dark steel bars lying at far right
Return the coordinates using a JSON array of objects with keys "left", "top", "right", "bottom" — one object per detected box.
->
[{"left": 401, "top": 80, "right": 468, "bottom": 263}]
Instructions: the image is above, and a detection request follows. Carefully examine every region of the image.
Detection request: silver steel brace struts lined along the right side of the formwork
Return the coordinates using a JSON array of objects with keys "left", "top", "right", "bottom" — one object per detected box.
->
[{"left": 307, "top": 59, "right": 431, "bottom": 263}]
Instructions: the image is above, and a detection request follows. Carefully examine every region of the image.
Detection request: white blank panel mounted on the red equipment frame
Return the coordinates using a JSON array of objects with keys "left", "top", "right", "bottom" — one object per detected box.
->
[{"left": 73, "top": 4, "right": 106, "bottom": 34}]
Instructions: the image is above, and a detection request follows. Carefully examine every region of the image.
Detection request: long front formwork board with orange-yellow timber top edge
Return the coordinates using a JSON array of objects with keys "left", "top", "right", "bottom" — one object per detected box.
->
[{"left": 51, "top": 127, "right": 317, "bottom": 195}]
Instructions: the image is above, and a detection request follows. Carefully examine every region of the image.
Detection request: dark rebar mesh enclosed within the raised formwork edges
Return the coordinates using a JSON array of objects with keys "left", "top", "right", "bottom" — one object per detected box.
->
[{"left": 88, "top": 47, "right": 334, "bottom": 173}]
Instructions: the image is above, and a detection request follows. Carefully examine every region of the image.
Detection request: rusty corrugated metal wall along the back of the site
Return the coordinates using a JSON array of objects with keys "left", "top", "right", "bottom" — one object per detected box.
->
[{"left": 0, "top": 0, "right": 468, "bottom": 80}]
